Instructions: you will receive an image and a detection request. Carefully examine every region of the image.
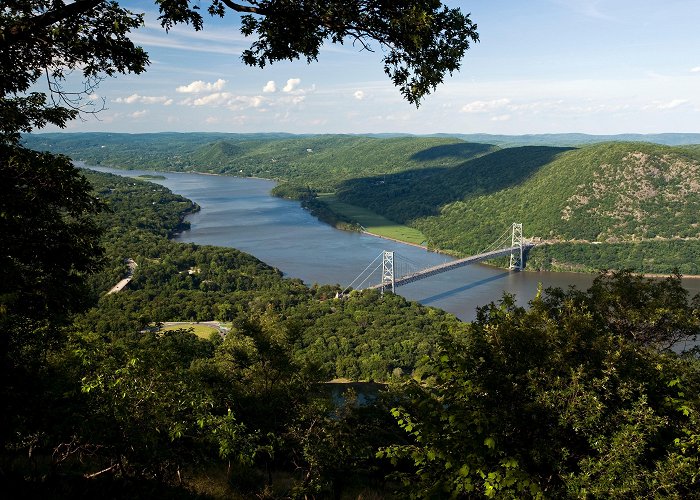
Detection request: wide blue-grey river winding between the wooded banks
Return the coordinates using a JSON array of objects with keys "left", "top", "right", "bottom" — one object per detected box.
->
[{"left": 90, "top": 167, "right": 700, "bottom": 321}]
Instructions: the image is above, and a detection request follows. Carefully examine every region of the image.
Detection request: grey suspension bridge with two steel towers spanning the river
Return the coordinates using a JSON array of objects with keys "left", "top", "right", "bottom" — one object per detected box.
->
[{"left": 343, "top": 223, "right": 534, "bottom": 293}]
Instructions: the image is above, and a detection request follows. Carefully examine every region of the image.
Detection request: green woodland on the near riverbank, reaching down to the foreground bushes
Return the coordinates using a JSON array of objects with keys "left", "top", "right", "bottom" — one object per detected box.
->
[{"left": 5, "top": 162, "right": 700, "bottom": 498}]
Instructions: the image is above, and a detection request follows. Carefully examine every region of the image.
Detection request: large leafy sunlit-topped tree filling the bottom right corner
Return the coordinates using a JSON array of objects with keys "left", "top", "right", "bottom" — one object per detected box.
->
[{"left": 381, "top": 273, "right": 700, "bottom": 498}]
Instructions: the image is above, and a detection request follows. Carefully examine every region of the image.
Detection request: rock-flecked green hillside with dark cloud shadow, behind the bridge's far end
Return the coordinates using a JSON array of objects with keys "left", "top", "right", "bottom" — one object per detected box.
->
[{"left": 339, "top": 143, "right": 700, "bottom": 274}]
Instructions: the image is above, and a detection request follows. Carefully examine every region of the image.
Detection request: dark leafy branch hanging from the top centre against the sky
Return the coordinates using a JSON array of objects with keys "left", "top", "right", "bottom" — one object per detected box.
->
[{"left": 158, "top": 0, "right": 479, "bottom": 106}]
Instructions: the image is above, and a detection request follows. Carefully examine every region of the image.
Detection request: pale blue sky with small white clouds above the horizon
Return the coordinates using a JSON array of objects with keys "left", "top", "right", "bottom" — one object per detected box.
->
[{"left": 44, "top": 0, "right": 700, "bottom": 134}]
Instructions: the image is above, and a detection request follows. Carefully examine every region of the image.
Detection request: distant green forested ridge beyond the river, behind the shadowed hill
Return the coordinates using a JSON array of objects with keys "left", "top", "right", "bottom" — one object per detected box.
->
[{"left": 25, "top": 133, "right": 498, "bottom": 189}]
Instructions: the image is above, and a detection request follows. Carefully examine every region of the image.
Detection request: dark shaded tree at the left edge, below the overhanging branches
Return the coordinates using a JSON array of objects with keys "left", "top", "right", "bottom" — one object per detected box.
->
[{"left": 0, "top": 144, "right": 102, "bottom": 450}]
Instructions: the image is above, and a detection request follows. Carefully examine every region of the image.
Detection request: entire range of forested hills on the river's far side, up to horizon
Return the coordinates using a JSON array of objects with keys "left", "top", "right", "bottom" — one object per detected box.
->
[{"left": 26, "top": 133, "right": 700, "bottom": 274}]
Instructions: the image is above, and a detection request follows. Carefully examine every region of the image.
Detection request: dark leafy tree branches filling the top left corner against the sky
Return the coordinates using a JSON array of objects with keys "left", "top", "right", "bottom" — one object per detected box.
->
[{"left": 0, "top": 0, "right": 148, "bottom": 143}]
